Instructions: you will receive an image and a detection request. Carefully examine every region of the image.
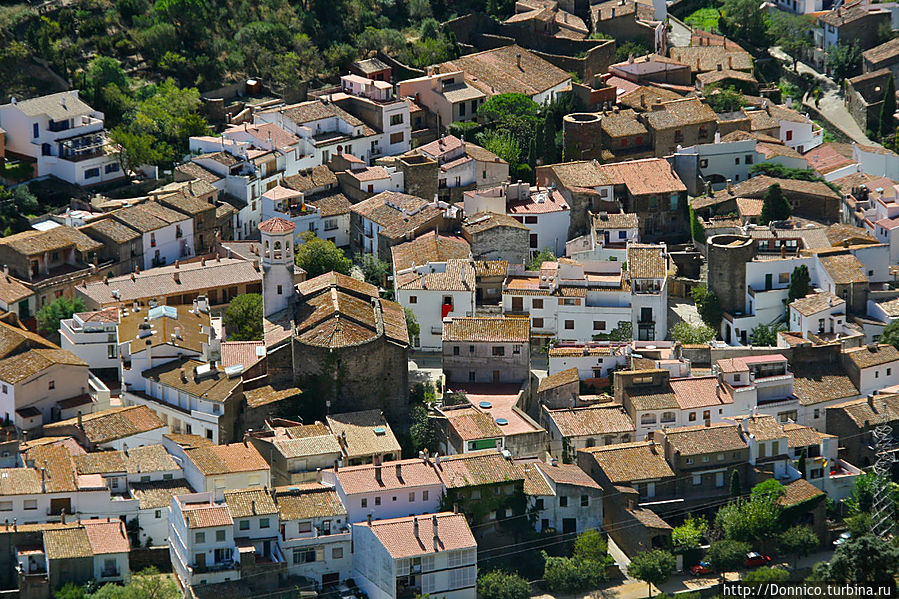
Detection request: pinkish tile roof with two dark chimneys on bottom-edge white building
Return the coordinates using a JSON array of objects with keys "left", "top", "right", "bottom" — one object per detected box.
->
[{"left": 354, "top": 512, "right": 477, "bottom": 559}]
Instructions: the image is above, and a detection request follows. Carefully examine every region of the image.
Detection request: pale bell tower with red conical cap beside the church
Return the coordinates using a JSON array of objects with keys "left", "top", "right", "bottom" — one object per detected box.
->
[{"left": 259, "top": 217, "right": 297, "bottom": 318}]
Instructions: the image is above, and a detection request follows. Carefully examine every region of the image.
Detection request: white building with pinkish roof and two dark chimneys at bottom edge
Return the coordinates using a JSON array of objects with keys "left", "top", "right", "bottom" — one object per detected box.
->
[{"left": 353, "top": 512, "right": 478, "bottom": 599}]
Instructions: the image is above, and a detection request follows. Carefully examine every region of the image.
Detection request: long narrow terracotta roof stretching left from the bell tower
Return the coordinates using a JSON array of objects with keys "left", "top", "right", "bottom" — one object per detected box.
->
[{"left": 77, "top": 258, "right": 262, "bottom": 306}]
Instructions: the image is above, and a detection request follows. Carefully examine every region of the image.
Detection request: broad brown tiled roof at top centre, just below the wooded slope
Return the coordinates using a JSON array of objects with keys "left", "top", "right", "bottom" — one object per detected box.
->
[{"left": 440, "top": 45, "right": 571, "bottom": 96}]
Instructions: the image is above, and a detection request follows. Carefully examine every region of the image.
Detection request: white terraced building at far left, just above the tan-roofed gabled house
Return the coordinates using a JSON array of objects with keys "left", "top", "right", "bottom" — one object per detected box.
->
[{"left": 59, "top": 308, "right": 119, "bottom": 369}]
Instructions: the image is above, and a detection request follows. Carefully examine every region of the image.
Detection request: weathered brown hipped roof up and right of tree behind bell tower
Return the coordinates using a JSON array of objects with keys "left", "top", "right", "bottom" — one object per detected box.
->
[{"left": 350, "top": 191, "right": 443, "bottom": 240}]
